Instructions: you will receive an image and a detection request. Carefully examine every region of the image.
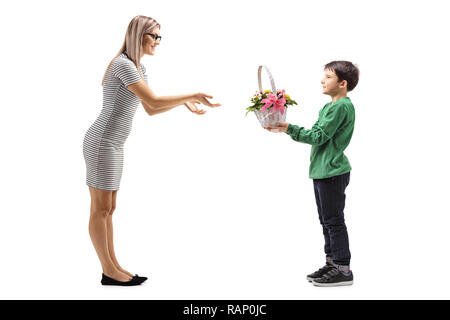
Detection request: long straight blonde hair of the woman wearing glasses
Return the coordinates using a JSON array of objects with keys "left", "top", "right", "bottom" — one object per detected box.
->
[{"left": 102, "top": 16, "right": 161, "bottom": 85}]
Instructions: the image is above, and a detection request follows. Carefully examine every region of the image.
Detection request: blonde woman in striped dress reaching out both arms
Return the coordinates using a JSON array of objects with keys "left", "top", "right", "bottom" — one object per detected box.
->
[{"left": 83, "top": 16, "right": 220, "bottom": 286}]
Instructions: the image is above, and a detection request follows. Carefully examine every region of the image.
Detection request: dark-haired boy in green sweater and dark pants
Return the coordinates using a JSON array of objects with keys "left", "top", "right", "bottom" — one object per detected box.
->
[{"left": 265, "top": 61, "right": 359, "bottom": 287}]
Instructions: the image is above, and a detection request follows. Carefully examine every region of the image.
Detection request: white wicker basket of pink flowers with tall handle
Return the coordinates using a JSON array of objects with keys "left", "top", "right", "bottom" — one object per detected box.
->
[{"left": 245, "top": 66, "right": 297, "bottom": 128}]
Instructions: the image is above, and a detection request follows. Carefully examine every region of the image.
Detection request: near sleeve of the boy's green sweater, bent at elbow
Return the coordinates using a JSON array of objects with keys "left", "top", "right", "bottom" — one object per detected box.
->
[{"left": 286, "top": 104, "right": 347, "bottom": 146}]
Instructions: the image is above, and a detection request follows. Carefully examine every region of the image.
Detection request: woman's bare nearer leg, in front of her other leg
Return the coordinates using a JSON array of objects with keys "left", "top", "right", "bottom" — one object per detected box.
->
[{"left": 89, "top": 187, "right": 131, "bottom": 281}]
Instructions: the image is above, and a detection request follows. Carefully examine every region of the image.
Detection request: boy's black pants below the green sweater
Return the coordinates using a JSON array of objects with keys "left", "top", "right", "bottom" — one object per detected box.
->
[{"left": 313, "top": 172, "right": 350, "bottom": 265}]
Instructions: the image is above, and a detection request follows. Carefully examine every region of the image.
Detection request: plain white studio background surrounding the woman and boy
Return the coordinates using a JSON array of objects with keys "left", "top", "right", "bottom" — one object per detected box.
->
[{"left": 0, "top": 0, "right": 450, "bottom": 299}]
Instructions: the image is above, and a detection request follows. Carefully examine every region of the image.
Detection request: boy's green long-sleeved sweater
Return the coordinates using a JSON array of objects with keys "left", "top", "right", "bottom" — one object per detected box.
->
[{"left": 286, "top": 97, "right": 355, "bottom": 179}]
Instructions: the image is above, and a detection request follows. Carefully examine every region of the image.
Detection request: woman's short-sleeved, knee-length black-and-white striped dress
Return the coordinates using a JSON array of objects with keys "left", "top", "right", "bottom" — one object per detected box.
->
[{"left": 83, "top": 53, "right": 147, "bottom": 191}]
